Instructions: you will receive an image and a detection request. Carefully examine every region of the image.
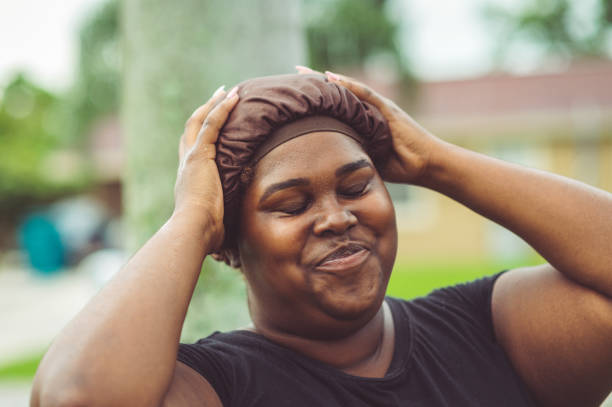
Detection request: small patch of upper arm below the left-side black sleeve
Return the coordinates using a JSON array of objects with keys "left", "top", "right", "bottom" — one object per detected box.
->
[{"left": 161, "top": 361, "right": 223, "bottom": 407}]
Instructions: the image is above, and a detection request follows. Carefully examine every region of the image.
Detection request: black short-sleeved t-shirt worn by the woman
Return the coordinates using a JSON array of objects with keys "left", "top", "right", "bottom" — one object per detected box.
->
[{"left": 178, "top": 275, "right": 534, "bottom": 407}]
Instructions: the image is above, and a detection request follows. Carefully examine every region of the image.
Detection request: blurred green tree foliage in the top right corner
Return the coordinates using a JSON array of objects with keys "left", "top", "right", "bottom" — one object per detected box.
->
[{"left": 485, "top": 0, "right": 612, "bottom": 57}]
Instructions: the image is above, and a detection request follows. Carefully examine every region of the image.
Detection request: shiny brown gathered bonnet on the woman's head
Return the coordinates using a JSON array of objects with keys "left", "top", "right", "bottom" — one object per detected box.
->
[{"left": 216, "top": 74, "right": 390, "bottom": 260}]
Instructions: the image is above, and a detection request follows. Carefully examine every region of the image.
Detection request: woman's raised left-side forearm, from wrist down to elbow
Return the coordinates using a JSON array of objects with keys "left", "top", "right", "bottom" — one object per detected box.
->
[{"left": 32, "top": 216, "right": 215, "bottom": 406}]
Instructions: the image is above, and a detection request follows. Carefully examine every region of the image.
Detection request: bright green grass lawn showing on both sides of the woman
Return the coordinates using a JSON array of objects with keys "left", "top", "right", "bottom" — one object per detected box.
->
[{"left": 0, "top": 259, "right": 539, "bottom": 381}]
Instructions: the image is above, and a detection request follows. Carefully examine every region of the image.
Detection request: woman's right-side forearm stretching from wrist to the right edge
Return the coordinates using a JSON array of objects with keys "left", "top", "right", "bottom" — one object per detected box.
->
[{"left": 420, "top": 142, "right": 612, "bottom": 297}]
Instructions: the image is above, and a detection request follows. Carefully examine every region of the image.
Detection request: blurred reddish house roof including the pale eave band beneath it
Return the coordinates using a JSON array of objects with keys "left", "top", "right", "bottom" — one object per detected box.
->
[{"left": 413, "top": 60, "right": 612, "bottom": 142}]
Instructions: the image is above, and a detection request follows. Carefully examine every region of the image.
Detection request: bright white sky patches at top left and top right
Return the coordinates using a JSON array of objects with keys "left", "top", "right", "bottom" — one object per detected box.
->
[{"left": 0, "top": 0, "right": 520, "bottom": 90}]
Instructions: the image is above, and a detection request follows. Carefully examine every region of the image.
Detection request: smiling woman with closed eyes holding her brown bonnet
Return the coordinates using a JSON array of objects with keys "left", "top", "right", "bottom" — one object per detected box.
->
[{"left": 32, "top": 69, "right": 612, "bottom": 406}]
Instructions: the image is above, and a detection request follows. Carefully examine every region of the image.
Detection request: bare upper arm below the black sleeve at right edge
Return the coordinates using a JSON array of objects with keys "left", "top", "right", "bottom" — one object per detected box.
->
[{"left": 492, "top": 265, "right": 612, "bottom": 406}]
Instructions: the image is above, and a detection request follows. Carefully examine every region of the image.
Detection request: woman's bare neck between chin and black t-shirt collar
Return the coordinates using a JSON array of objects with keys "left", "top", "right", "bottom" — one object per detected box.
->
[{"left": 247, "top": 302, "right": 395, "bottom": 377}]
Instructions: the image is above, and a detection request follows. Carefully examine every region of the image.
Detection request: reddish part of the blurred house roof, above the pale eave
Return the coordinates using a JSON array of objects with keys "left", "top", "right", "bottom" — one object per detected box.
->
[{"left": 418, "top": 61, "right": 612, "bottom": 116}]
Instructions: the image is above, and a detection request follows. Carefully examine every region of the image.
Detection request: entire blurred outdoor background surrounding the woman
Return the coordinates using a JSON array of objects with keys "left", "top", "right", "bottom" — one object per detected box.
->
[{"left": 0, "top": 0, "right": 612, "bottom": 406}]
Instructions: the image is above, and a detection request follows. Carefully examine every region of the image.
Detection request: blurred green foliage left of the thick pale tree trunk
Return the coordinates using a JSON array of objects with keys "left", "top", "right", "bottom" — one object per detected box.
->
[{"left": 0, "top": 0, "right": 120, "bottom": 220}]
